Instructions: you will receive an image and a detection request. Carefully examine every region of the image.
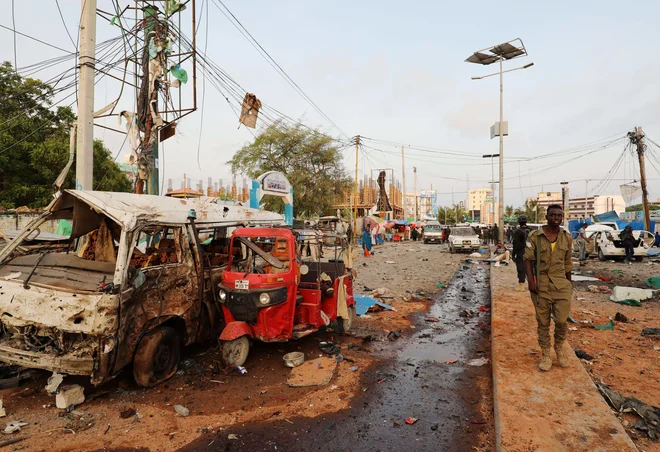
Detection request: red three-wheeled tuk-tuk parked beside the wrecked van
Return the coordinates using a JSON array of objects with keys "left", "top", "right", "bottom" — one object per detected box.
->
[{"left": 218, "top": 228, "right": 355, "bottom": 367}]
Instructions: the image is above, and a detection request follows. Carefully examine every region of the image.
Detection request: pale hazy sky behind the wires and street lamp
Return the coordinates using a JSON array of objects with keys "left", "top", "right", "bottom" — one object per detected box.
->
[{"left": 0, "top": 0, "right": 660, "bottom": 206}]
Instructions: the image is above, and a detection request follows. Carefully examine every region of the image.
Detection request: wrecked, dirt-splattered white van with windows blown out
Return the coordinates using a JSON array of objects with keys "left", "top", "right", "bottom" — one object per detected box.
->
[{"left": 0, "top": 190, "right": 283, "bottom": 387}]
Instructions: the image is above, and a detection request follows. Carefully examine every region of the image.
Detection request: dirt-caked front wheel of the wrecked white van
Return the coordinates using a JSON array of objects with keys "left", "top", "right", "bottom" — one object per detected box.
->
[{"left": 133, "top": 326, "right": 181, "bottom": 388}]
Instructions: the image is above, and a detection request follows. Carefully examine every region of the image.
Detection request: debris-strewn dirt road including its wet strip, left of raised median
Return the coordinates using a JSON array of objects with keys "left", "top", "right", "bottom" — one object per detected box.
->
[{"left": 0, "top": 242, "right": 492, "bottom": 451}]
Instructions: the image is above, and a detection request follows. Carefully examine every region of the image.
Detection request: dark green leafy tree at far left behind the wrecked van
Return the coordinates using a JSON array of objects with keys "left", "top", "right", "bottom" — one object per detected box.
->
[{"left": 0, "top": 62, "right": 132, "bottom": 209}]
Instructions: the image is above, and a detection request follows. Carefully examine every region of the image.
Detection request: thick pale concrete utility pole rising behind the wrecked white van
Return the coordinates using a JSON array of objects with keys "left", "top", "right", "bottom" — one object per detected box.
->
[{"left": 76, "top": 0, "right": 96, "bottom": 190}]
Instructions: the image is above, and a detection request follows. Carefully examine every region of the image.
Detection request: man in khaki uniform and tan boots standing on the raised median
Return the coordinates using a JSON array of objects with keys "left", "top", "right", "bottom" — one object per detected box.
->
[{"left": 525, "top": 204, "right": 573, "bottom": 371}]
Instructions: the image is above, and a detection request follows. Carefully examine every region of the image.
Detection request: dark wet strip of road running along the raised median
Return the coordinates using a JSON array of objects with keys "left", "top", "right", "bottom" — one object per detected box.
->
[{"left": 181, "top": 261, "right": 493, "bottom": 451}]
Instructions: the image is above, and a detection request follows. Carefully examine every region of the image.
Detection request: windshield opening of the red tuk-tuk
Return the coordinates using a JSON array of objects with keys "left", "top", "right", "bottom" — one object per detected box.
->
[{"left": 230, "top": 236, "right": 290, "bottom": 274}]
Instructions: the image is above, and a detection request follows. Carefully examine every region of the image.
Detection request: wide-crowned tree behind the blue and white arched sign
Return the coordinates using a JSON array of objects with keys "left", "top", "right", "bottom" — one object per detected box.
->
[{"left": 227, "top": 122, "right": 353, "bottom": 218}]
